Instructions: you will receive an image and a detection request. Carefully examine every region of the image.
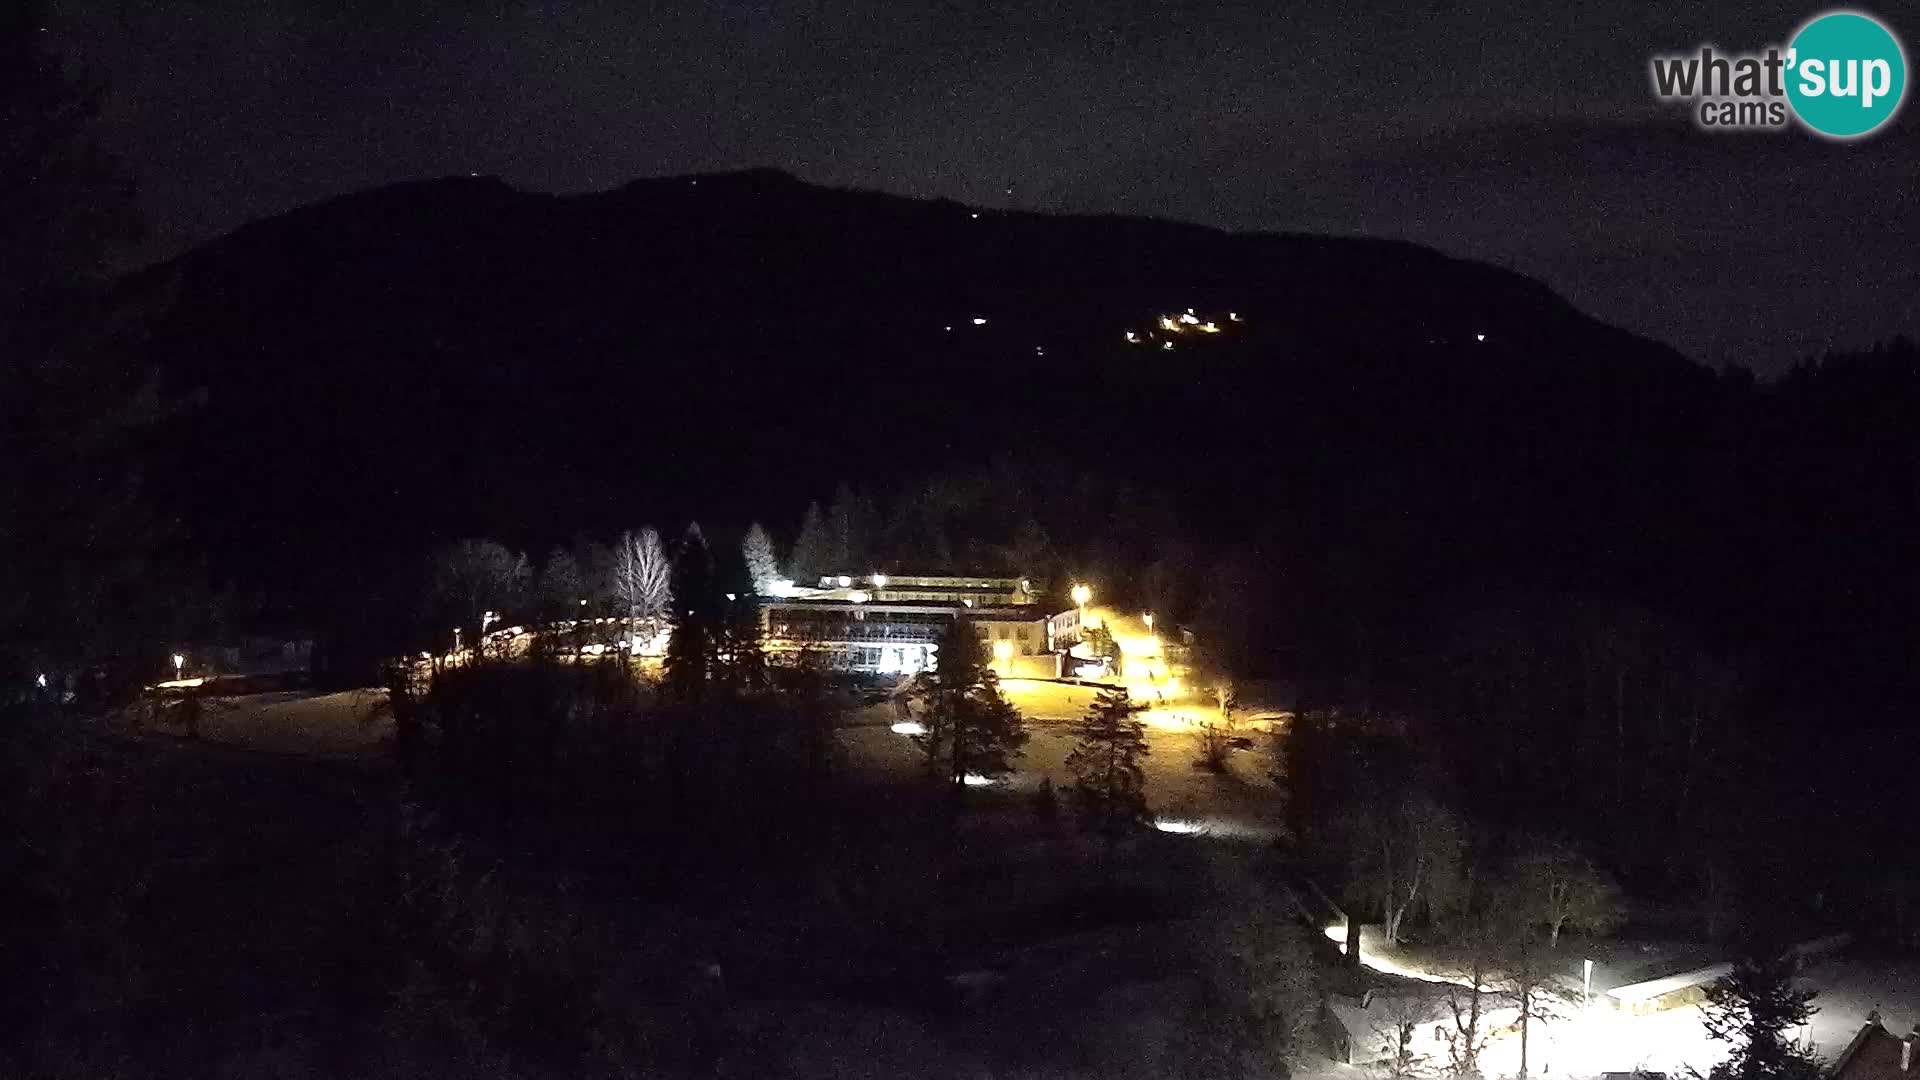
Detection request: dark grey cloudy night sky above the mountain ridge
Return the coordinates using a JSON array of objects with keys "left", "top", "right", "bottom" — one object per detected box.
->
[{"left": 48, "top": 0, "right": 1920, "bottom": 373}]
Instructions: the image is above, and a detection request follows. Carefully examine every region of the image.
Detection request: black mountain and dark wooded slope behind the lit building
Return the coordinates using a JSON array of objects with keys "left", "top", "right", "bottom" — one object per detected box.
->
[{"left": 105, "top": 171, "right": 1920, "bottom": 907}]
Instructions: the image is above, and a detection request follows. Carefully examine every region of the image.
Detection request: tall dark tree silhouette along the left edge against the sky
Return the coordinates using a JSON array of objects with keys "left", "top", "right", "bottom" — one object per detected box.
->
[{"left": 0, "top": 0, "right": 173, "bottom": 680}]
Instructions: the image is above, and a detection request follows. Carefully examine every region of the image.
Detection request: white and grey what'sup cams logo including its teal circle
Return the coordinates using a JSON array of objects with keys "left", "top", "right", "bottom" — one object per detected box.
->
[{"left": 1651, "top": 12, "right": 1907, "bottom": 138}]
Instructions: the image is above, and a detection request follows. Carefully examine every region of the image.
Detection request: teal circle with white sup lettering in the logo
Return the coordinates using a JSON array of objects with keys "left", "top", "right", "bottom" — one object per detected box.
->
[{"left": 1788, "top": 12, "right": 1907, "bottom": 138}]
